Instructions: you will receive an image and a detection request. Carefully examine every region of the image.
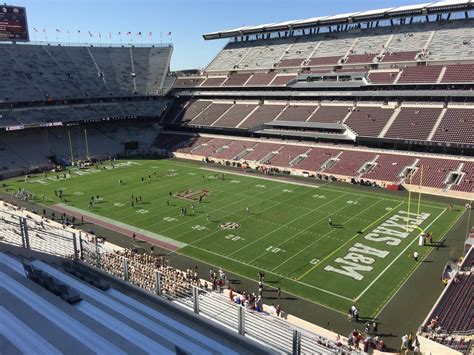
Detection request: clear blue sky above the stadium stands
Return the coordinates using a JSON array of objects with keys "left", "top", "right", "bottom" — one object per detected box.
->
[{"left": 17, "top": 0, "right": 429, "bottom": 70}]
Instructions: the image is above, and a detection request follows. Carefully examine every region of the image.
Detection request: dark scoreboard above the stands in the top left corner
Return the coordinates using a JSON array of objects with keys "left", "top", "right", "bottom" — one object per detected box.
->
[{"left": 0, "top": 5, "right": 30, "bottom": 42}]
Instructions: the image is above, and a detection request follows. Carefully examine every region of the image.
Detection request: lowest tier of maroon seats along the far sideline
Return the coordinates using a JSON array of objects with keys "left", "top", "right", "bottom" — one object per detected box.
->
[{"left": 160, "top": 133, "right": 474, "bottom": 193}]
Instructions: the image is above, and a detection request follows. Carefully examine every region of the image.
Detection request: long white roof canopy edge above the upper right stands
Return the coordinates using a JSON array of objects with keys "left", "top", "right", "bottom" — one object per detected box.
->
[{"left": 203, "top": 0, "right": 474, "bottom": 40}]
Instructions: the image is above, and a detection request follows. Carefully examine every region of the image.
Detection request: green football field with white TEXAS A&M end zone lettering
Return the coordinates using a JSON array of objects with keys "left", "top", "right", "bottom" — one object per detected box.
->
[{"left": 7, "top": 160, "right": 464, "bottom": 316}]
